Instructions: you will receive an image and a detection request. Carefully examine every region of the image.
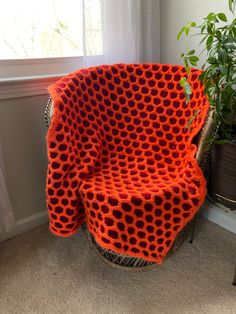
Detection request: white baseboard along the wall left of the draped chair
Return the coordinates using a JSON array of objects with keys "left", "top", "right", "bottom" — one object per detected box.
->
[{"left": 0, "top": 211, "right": 48, "bottom": 242}]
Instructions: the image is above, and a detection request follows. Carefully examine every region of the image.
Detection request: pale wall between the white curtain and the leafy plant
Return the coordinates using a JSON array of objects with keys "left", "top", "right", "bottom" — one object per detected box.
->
[{"left": 161, "top": 0, "right": 232, "bottom": 64}]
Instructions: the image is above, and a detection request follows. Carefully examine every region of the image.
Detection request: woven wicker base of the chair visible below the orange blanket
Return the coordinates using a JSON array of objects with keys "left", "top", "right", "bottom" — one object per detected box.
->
[{"left": 82, "top": 220, "right": 193, "bottom": 272}]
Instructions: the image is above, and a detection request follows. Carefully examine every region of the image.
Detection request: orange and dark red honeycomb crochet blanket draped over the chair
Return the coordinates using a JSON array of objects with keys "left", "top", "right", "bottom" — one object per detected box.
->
[{"left": 47, "top": 64, "right": 209, "bottom": 263}]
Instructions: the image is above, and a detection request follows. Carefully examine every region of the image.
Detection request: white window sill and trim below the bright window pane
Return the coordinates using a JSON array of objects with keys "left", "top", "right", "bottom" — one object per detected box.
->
[{"left": 0, "top": 55, "right": 104, "bottom": 100}]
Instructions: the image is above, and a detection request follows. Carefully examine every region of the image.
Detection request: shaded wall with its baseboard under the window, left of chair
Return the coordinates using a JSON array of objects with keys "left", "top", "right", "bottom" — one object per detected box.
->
[{"left": 0, "top": 88, "right": 48, "bottom": 241}]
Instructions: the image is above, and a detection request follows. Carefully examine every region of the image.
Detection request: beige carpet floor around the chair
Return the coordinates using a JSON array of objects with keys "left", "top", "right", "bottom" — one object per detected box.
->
[{"left": 0, "top": 220, "right": 236, "bottom": 314}]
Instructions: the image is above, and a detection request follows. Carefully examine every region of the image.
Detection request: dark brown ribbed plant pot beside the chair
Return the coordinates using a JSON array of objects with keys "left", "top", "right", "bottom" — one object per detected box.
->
[{"left": 208, "top": 142, "right": 236, "bottom": 210}]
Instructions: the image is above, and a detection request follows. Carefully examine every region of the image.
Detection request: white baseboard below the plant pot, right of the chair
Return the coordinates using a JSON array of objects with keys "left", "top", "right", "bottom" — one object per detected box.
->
[{"left": 201, "top": 200, "right": 236, "bottom": 234}]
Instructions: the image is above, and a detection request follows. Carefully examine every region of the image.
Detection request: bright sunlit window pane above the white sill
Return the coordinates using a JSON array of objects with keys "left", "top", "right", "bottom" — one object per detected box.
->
[{"left": 0, "top": 0, "right": 102, "bottom": 59}]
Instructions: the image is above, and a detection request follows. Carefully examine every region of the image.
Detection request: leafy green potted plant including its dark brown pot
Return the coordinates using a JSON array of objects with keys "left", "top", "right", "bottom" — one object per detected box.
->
[{"left": 177, "top": 0, "right": 236, "bottom": 210}]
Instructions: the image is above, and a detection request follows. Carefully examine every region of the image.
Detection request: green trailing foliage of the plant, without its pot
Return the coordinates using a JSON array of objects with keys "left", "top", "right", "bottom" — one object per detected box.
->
[{"left": 177, "top": 0, "right": 236, "bottom": 143}]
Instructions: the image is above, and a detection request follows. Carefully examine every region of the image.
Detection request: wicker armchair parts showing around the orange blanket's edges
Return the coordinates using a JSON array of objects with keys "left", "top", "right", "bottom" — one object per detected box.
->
[{"left": 45, "top": 63, "right": 215, "bottom": 270}]
